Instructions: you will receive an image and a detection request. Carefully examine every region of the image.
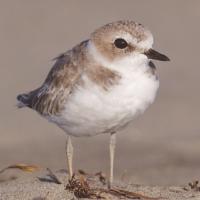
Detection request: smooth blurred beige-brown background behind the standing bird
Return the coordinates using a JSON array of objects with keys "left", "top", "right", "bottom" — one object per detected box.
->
[{"left": 0, "top": 0, "right": 200, "bottom": 185}]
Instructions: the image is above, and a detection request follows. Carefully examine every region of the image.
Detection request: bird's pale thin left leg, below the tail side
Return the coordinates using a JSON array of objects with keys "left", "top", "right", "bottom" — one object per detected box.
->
[{"left": 66, "top": 136, "right": 73, "bottom": 179}]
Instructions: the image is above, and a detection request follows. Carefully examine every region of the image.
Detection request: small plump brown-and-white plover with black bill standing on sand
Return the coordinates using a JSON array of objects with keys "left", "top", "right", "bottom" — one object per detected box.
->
[{"left": 17, "top": 20, "right": 170, "bottom": 188}]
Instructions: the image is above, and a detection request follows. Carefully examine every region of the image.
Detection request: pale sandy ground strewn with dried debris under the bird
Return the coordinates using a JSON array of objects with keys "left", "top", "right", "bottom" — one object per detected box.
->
[{"left": 0, "top": 172, "right": 200, "bottom": 200}]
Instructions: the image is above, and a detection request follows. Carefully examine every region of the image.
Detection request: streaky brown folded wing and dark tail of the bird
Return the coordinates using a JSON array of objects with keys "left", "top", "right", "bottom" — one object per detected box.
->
[{"left": 17, "top": 52, "right": 82, "bottom": 115}]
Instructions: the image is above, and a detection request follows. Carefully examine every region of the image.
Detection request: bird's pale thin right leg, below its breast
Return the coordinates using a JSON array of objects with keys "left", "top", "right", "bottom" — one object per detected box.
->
[{"left": 108, "top": 133, "right": 116, "bottom": 189}]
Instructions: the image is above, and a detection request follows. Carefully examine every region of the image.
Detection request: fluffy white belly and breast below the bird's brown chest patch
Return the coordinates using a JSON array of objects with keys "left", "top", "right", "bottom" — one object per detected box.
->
[{"left": 51, "top": 63, "right": 159, "bottom": 136}]
